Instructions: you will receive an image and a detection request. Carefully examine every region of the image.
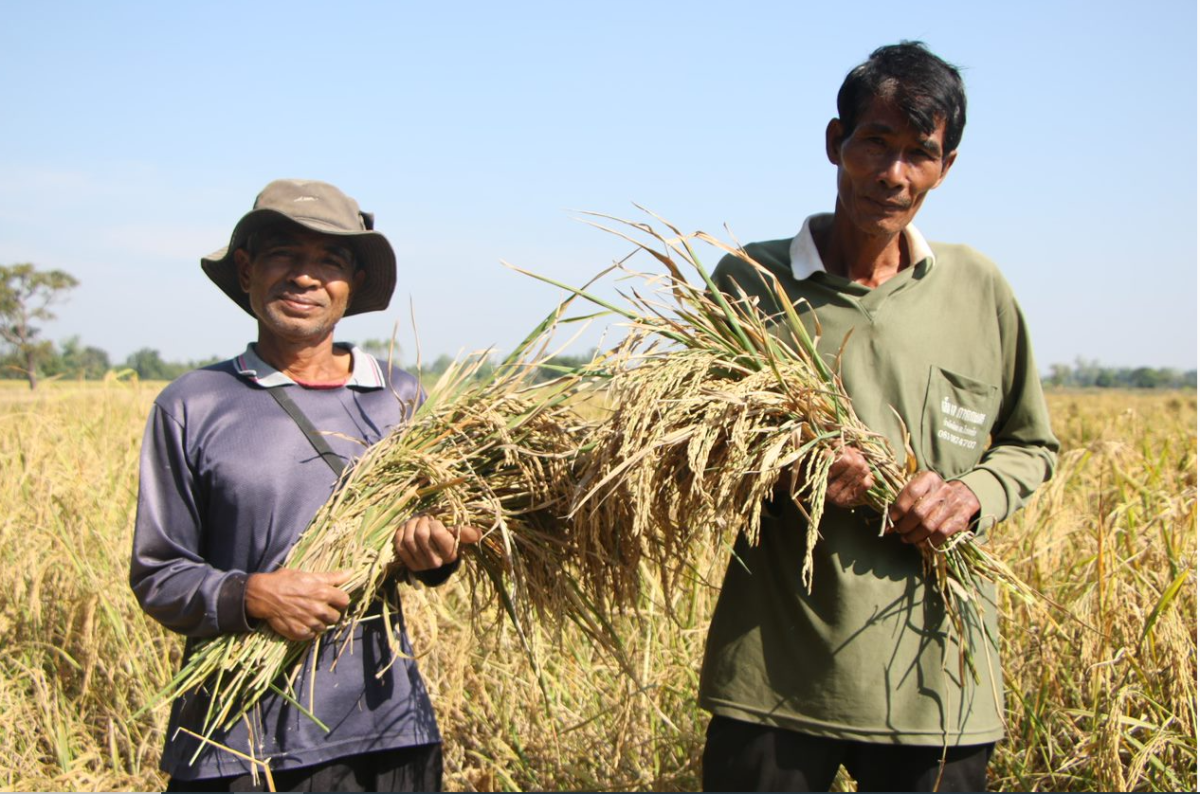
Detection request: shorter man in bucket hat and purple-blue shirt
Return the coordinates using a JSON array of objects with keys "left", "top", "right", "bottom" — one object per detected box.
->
[{"left": 130, "top": 180, "right": 479, "bottom": 790}]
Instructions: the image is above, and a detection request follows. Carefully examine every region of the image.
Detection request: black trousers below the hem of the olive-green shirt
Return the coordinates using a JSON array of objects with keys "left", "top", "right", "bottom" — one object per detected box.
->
[{"left": 703, "top": 716, "right": 996, "bottom": 792}]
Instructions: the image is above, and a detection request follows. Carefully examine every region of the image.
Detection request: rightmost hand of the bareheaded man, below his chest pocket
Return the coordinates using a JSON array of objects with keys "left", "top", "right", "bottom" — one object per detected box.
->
[{"left": 888, "top": 471, "right": 979, "bottom": 547}]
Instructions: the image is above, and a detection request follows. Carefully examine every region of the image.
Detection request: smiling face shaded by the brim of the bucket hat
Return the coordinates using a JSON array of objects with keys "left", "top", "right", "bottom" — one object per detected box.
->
[{"left": 234, "top": 228, "right": 365, "bottom": 342}]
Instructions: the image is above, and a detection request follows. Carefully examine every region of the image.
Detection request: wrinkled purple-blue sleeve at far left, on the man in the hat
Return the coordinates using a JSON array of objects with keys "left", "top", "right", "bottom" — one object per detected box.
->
[{"left": 130, "top": 404, "right": 250, "bottom": 637}]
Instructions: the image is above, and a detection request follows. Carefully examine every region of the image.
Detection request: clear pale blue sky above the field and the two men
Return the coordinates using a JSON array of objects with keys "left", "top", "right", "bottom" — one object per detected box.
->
[{"left": 0, "top": 0, "right": 1196, "bottom": 369}]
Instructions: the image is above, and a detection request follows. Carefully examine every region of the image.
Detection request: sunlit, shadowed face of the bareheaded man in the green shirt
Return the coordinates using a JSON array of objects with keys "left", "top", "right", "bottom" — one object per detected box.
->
[{"left": 826, "top": 97, "right": 956, "bottom": 235}]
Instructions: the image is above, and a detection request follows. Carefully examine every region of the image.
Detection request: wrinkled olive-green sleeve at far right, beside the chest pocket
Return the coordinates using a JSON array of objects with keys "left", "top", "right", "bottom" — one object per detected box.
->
[{"left": 955, "top": 283, "right": 1058, "bottom": 535}]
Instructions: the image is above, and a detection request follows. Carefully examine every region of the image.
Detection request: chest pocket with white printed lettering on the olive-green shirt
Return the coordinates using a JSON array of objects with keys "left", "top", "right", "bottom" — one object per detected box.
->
[{"left": 920, "top": 367, "right": 1000, "bottom": 477}]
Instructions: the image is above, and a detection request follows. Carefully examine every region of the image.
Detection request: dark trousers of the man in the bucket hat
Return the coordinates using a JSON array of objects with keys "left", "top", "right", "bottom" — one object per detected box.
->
[{"left": 167, "top": 745, "right": 442, "bottom": 792}]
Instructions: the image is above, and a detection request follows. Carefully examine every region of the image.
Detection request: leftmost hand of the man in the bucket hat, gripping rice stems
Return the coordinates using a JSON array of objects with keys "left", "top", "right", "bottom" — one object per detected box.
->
[{"left": 246, "top": 569, "right": 350, "bottom": 640}]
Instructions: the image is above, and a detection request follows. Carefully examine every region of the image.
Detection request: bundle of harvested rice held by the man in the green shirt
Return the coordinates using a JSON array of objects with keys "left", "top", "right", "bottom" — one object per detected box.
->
[{"left": 525, "top": 216, "right": 1034, "bottom": 678}]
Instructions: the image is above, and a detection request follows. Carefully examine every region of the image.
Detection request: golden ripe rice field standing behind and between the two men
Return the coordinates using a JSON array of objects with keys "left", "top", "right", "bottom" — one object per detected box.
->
[{"left": 0, "top": 380, "right": 1196, "bottom": 790}]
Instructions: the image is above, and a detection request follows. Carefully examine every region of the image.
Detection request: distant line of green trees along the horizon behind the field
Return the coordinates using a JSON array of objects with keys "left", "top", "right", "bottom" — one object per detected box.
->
[{"left": 0, "top": 263, "right": 1196, "bottom": 389}]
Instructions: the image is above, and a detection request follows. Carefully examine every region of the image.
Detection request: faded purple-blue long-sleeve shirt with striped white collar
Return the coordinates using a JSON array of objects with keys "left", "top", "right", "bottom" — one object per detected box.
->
[{"left": 130, "top": 345, "right": 444, "bottom": 780}]
